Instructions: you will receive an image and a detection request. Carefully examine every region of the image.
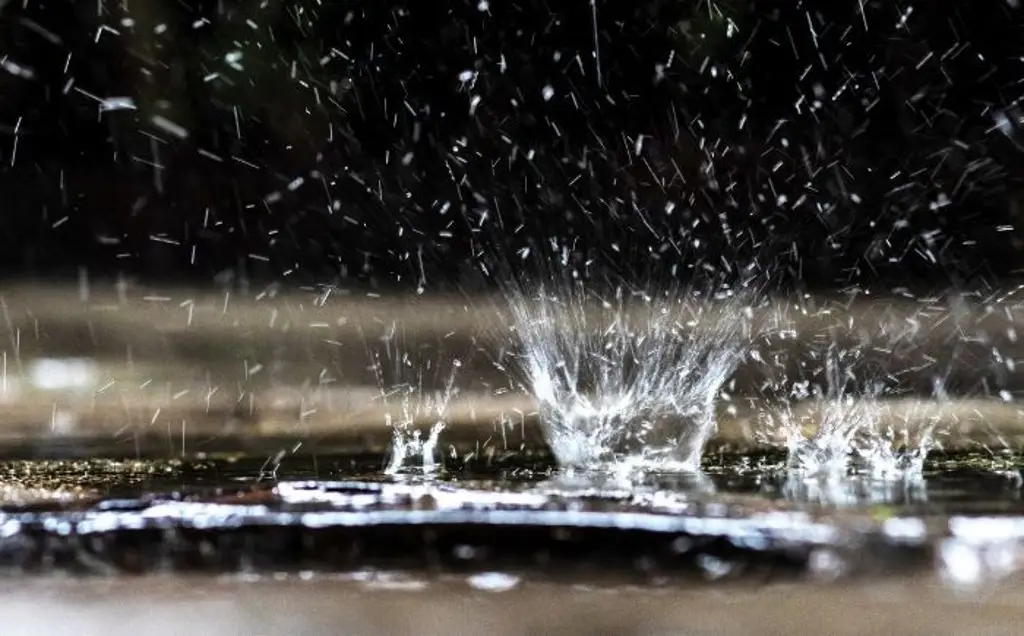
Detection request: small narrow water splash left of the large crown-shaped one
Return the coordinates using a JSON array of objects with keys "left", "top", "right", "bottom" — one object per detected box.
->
[{"left": 370, "top": 325, "right": 462, "bottom": 475}]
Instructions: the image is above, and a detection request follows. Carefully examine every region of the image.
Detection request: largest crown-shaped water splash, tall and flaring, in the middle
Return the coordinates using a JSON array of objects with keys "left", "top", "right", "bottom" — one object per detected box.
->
[{"left": 510, "top": 282, "right": 744, "bottom": 471}]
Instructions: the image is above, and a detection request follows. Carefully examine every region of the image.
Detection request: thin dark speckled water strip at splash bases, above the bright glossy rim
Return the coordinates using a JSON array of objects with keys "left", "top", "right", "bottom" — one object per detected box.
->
[{"left": 12, "top": 450, "right": 1024, "bottom": 503}]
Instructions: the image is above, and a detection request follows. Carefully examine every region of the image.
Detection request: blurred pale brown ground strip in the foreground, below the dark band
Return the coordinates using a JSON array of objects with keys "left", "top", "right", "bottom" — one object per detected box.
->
[{"left": 8, "top": 571, "right": 1024, "bottom": 636}]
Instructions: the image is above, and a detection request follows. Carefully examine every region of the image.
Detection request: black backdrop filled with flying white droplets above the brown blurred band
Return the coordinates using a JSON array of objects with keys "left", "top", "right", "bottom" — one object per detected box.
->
[{"left": 0, "top": 0, "right": 1024, "bottom": 291}]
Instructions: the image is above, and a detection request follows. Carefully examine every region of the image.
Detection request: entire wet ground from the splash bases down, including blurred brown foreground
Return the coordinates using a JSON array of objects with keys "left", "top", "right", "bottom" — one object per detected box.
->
[{"left": 0, "top": 453, "right": 1024, "bottom": 635}]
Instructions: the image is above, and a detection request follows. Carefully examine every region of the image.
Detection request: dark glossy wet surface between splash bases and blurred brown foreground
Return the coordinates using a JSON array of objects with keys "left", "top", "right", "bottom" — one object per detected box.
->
[{"left": 0, "top": 453, "right": 1024, "bottom": 585}]
